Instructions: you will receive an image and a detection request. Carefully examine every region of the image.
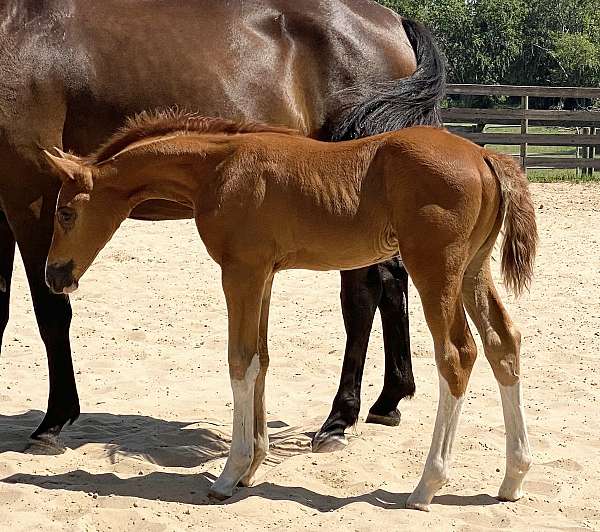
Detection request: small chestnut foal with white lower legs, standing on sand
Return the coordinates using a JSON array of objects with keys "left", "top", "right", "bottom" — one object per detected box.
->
[{"left": 46, "top": 113, "right": 537, "bottom": 509}]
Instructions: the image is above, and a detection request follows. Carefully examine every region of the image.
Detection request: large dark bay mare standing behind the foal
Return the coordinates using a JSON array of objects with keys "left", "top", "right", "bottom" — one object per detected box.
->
[{"left": 0, "top": 0, "right": 444, "bottom": 449}]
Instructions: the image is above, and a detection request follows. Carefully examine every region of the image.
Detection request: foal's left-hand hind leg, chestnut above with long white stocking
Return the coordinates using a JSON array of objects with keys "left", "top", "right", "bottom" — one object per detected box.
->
[{"left": 403, "top": 246, "right": 477, "bottom": 510}]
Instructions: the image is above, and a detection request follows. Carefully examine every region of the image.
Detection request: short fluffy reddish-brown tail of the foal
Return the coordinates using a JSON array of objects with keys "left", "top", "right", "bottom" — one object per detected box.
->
[{"left": 484, "top": 150, "right": 538, "bottom": 295}]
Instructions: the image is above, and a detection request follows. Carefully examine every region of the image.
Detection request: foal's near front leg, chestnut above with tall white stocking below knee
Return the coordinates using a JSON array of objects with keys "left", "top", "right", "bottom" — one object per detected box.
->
[{"left": 210, "top": 265, "right": 269, "bottom": 499}]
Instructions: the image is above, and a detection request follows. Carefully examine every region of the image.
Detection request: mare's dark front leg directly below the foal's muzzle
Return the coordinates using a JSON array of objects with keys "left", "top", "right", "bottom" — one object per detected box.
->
[{"left": 7, "top": 197, "right": 79, "bottom": 448}]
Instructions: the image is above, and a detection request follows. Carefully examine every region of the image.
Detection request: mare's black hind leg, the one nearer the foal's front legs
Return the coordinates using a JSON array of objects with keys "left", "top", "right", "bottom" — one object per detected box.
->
[{"left": 312, "top": 266, "right": 382, "bottom": 451}]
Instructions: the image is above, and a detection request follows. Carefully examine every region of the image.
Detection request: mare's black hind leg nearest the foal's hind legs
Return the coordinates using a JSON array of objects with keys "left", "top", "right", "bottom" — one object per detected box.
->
[{"left": 367, "top": 259, "right": 415, "bottom": 426}]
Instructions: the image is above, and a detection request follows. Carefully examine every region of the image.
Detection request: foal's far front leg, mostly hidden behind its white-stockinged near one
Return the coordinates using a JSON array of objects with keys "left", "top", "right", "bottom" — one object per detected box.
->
[{"left": 240, "top": 276, "right": 273, "bottom": 486}]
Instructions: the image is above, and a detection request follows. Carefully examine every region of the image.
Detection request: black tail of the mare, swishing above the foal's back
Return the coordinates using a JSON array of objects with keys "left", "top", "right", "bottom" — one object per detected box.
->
[{"left": 323, "top": 19, "right": 446, "bottom": 141}]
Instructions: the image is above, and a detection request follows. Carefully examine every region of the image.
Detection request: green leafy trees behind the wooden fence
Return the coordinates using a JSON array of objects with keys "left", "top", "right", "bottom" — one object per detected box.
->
[{"left": 380, "top": 0, "right": 600, "bottom": 86}]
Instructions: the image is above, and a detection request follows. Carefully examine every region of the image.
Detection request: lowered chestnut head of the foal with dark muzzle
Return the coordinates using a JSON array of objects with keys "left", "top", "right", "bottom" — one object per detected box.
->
[{"left": 45, "top": 150, "right": 130, "bottom": 294}]
